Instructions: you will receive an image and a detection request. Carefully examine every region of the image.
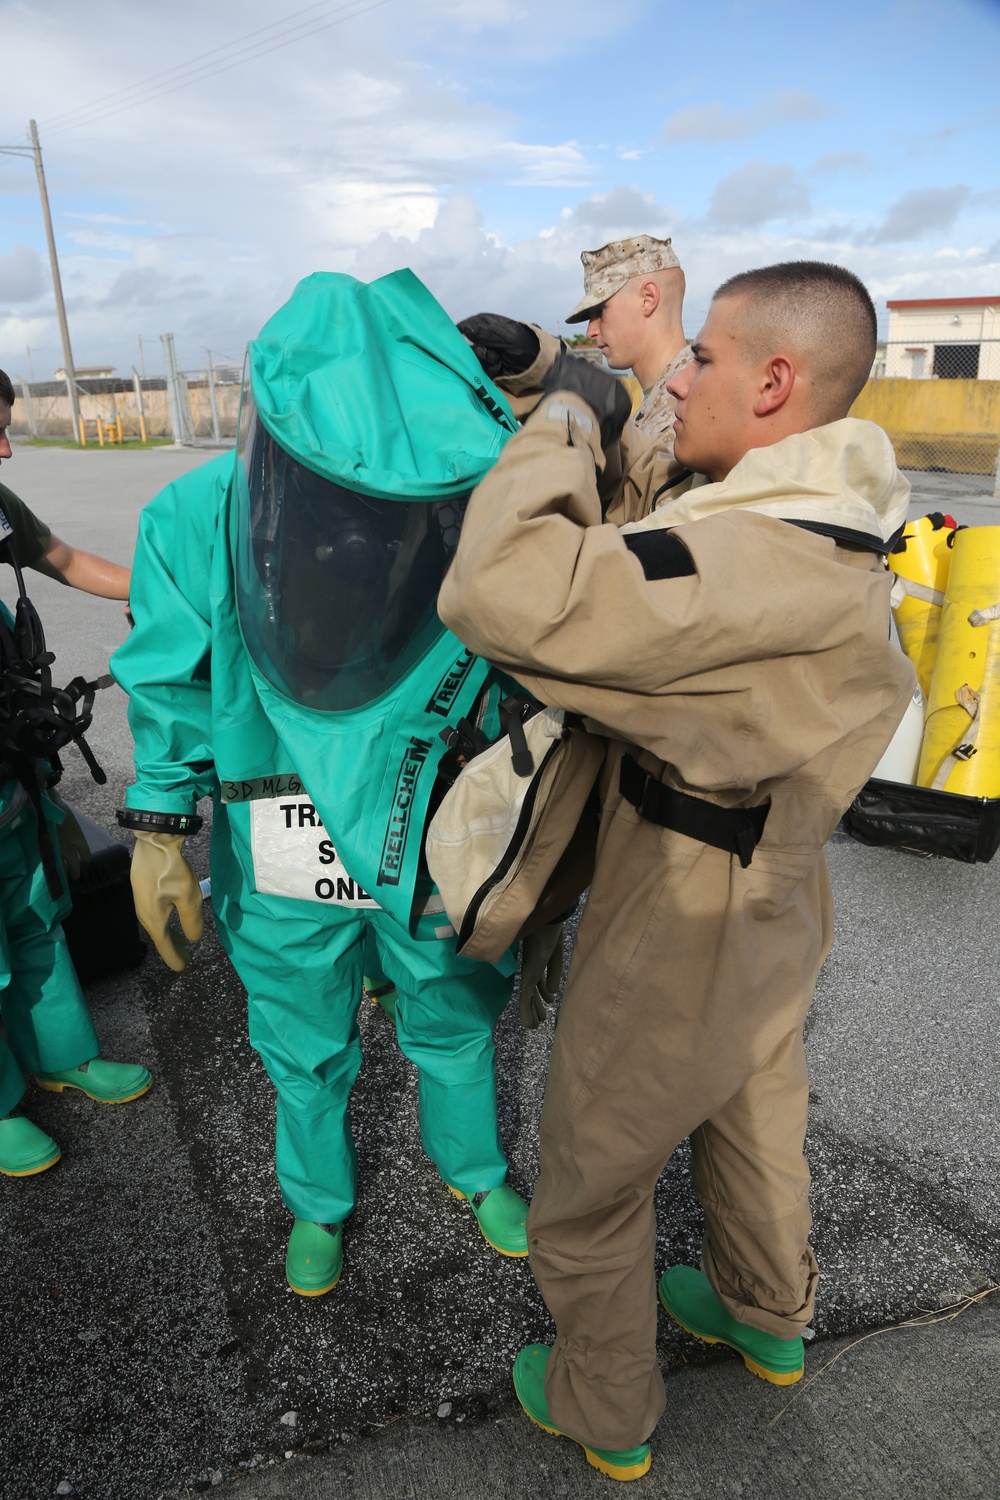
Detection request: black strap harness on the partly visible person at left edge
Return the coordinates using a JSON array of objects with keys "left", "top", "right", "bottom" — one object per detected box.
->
[{"left": 0, "top": 531, "right": 114, "bottom": 899}]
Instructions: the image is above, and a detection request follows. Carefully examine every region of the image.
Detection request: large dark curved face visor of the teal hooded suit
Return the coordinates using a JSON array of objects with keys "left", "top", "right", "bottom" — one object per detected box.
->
[{"left": 235, "top": 381, "right": 468, "bottom": 711}]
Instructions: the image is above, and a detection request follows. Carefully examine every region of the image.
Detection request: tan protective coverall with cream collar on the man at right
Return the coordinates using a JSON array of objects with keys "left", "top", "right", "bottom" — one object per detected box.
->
[{"left": 439, "top": 393, "right": 913, "bottom": 1449}]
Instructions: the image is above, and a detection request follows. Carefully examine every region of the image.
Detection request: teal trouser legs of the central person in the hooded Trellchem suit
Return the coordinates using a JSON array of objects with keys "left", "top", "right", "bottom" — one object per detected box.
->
[{"left": 211, "top": 806, "right": 511, "bottom": 1224}]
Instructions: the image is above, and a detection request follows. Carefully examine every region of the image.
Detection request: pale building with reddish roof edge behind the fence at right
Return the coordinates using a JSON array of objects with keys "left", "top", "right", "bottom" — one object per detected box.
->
[{"left": 885, "top": 296, "right": 1000, "bottom": 380}]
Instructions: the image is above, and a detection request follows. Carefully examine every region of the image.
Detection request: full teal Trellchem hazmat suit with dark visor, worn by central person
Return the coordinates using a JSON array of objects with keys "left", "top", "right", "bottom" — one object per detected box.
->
[{"left": 111, "top": 272, "right": 516, "bottom": 1224}]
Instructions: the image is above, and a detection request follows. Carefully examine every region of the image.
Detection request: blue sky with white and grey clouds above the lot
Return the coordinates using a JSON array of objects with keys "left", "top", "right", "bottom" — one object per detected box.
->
[{"left": 0, "top": 0, "right": 1000, "bottom": 380}]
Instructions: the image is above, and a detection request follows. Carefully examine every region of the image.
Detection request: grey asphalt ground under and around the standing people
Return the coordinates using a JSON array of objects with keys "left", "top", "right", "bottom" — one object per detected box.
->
[{"left": 0, "top": 447, "right": 1000, "bottom": 1500}]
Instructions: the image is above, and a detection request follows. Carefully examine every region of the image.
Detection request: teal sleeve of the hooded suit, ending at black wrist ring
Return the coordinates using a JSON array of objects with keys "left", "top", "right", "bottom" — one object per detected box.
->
[{"left": 111, "top": 453, "right": 235, "bottom": 813}]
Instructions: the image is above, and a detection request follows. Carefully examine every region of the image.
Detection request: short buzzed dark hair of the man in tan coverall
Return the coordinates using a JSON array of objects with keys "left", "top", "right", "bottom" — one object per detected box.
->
[{"left": 715, "top": 261, "right": 877, "bottom": 422}]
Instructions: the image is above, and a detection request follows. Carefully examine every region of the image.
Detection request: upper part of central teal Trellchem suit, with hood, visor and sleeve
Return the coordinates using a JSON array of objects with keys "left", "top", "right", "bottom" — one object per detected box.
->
[{"left": 119, "top": 270, "right": 517, "bottom": 932}]
